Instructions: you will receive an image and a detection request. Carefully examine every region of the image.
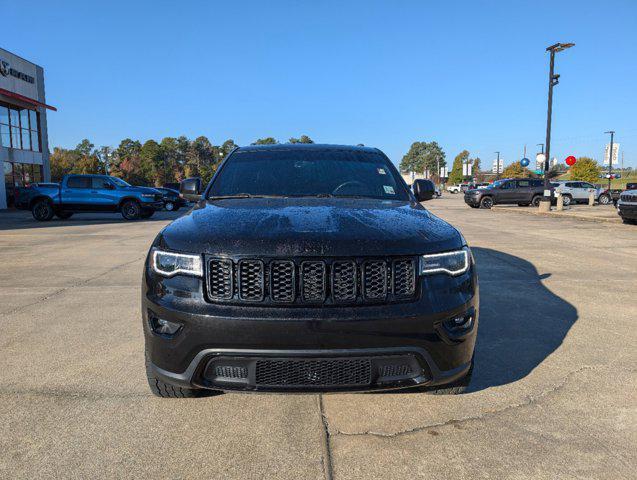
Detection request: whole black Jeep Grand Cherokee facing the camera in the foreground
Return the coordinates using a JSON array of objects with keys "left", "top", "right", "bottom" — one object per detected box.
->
[{"left": 142, "top": 144, "right": 478, "bottom": 397}]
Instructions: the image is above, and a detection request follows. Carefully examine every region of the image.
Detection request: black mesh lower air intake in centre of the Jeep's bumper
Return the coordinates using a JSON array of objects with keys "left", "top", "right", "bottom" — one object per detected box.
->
[{"left": 256, "top": 358, "right": 372, "bottom": 387}]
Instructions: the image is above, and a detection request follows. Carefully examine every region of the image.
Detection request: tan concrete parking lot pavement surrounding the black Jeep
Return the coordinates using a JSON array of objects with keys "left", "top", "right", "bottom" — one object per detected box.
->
[{"left": 0, "top": 195, "right": 637, "bottom": 479}]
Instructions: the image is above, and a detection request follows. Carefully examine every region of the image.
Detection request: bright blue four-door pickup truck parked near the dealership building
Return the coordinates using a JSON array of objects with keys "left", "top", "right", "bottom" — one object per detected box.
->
[{"left": 19, "top": 175, "right": 164, "bottom": 222}]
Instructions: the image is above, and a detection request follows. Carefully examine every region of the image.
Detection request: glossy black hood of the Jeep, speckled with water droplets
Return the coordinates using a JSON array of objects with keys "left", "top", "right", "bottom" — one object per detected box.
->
[{"left": 155, "top": 198, "right": 463, "bottom": 257}]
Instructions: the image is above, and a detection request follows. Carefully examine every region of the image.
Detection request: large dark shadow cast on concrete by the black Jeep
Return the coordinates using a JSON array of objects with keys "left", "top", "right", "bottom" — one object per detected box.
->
[{"left": 469, "top": 248, "right": 578, "bottom": 391}]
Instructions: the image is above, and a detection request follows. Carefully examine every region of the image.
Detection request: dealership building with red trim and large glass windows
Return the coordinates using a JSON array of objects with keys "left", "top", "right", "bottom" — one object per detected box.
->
[{"left": 0, "top": 48, "right": 55, "bottom": 209}]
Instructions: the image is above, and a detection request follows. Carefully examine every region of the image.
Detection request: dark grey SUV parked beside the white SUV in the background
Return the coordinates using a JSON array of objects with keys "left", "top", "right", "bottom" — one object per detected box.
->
[{"left": 464, "top": 178, "right": 544, "bottom": 208}]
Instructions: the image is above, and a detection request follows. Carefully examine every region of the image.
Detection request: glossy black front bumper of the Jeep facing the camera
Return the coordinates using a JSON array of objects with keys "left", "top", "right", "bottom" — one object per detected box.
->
[{"left": 142, "top": 267, "right": 479, "bottom": 392}]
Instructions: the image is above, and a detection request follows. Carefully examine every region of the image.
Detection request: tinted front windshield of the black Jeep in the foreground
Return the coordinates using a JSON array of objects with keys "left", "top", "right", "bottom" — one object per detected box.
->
[{"left": 208, "top": 149, "right": 409, "bottom": 200}]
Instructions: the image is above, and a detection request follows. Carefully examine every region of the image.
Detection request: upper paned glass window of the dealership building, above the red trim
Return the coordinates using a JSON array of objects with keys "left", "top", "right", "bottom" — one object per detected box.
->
[{"left": 0, "top": 104, "right": 41, "bottom": 152}]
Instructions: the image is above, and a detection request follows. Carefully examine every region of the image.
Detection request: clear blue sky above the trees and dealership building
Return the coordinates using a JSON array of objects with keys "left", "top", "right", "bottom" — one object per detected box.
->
[{"left": 0, "top": 0, "right": 637, "bottom": 170}]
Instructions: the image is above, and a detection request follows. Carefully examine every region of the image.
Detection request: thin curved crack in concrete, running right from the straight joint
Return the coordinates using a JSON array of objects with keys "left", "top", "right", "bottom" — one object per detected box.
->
[{"left": 324, "top": 365, "right": 596, "bottom": 438}]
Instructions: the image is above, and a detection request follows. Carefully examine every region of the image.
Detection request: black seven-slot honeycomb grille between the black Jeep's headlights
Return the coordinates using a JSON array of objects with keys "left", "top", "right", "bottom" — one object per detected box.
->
[{"left": 207, "top": 257, "right": 416, "bottom": 304}]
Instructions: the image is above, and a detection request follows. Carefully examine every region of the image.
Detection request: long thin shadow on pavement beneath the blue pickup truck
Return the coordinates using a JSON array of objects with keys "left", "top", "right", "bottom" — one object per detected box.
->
[{"left": 0, "top": 208, "right": 185, "bottom": 231}]
